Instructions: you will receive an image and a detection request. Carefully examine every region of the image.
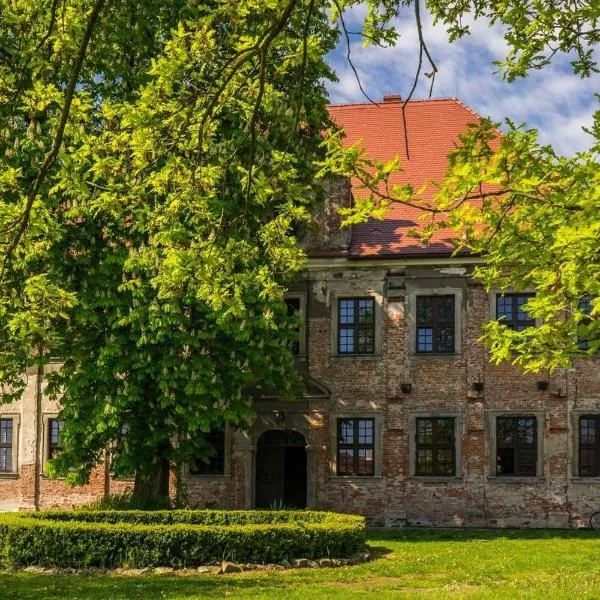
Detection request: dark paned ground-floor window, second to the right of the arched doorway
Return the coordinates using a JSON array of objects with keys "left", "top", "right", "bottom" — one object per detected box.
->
[{"left": 415, "top": 417, "right": 456, "bottom": 476}]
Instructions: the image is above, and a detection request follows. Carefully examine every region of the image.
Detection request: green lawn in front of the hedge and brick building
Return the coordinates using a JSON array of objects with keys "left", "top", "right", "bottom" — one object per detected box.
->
[{"left": 0, "top": 529, "right": 600, "bottom": 600}]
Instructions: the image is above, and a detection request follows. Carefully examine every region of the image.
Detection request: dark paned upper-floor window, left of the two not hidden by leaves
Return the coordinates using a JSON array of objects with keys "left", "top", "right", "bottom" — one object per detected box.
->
[{"left": 338, "top": 298, "right": 375, "bottom": 354}]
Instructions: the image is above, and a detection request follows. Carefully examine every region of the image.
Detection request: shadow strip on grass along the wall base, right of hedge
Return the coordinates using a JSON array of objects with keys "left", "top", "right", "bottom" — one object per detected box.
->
[{"left": 367, "top": 527, "right": 600, "bottom": 543}]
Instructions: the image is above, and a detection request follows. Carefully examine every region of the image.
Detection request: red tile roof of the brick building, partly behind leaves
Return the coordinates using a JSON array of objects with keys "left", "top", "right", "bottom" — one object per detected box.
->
[{"left": 329, "top": 98, "right": 480, "bottom": 258}]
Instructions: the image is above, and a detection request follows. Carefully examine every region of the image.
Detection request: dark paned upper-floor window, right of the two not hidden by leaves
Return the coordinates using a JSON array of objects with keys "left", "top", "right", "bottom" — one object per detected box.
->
[{"left": 416, "top": 295, "right": 455, "bottom": 354}]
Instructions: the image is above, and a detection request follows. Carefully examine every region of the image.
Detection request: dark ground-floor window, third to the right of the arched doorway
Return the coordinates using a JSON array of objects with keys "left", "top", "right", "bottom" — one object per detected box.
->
[{"left": 496, "top": 417, "right": 537, "bottom": 477}]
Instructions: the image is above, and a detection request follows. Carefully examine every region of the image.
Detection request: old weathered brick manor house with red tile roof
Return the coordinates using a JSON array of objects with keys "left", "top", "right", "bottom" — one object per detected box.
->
[{"left": 0, "top": 97, "right": 600, "bottom": 527}]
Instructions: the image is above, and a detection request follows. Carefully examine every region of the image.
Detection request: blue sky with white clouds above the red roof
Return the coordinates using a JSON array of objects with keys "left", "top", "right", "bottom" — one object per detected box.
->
[{"left": 328, "top": 9, "right": 600, "bottom": 155}]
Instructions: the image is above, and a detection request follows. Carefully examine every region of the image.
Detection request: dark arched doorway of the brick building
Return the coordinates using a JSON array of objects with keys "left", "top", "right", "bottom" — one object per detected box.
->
[{"left": 256, "top": 429, "right": 307, "bottom": 508}]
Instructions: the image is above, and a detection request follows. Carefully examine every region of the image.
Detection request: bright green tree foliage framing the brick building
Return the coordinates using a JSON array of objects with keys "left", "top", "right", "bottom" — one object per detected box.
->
[{"left": 0, "top": 0, "right": 600, "bottom": 491}]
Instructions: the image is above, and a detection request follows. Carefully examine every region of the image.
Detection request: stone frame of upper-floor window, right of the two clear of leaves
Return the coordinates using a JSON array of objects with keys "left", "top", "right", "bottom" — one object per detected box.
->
[{"left": 406, "top": 286, "right": 464, "bottom": 359}]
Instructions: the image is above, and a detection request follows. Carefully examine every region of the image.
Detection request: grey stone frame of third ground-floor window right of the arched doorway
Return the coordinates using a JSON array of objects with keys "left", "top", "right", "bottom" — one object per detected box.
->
[{"left": 486, "top": 408, "right": 547, "bottom": 483}]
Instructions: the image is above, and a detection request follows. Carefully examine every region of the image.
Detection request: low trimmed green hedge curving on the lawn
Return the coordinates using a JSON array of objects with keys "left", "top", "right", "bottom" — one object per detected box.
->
[{"left": 0, "top": 510, "right": 365, "bottom": 568}]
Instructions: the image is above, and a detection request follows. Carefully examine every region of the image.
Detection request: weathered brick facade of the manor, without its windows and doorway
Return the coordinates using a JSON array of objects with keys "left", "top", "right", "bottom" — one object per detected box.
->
[{"left": 0, "top": 265, "right": 600, "bottom": 527}]
